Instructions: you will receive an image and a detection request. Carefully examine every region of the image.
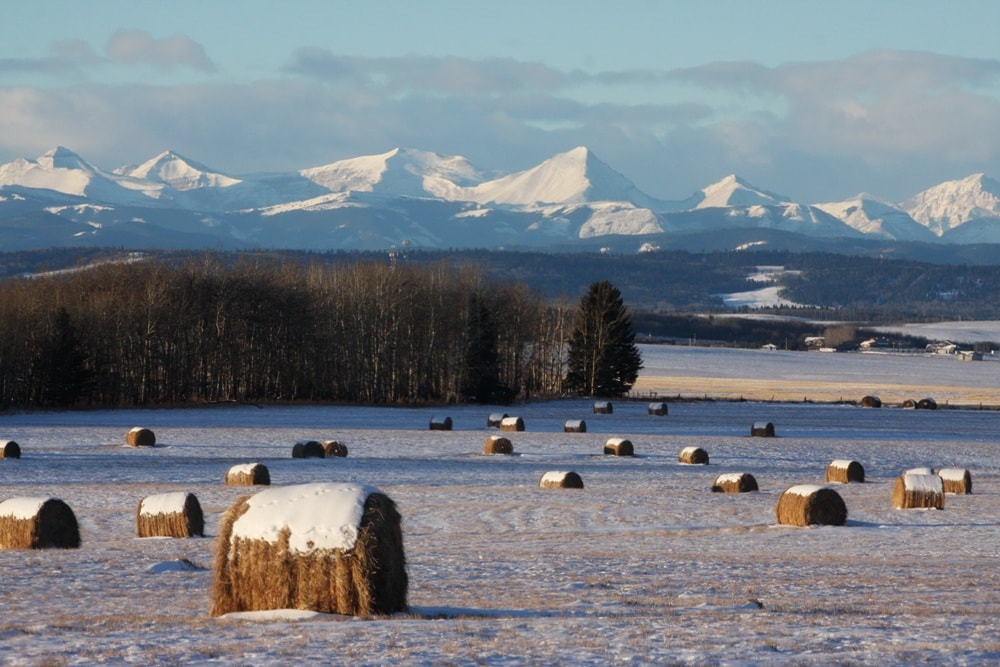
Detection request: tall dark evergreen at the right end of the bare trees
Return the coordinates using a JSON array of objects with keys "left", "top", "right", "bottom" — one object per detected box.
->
[{"left": 566, "top": 280, "right": 642, "bottom": 397}]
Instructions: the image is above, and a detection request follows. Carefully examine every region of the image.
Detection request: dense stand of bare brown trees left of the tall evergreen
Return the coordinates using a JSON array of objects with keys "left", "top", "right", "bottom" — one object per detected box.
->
[{"left": 0, "top": 255, "right": 634, "bottom": 409}]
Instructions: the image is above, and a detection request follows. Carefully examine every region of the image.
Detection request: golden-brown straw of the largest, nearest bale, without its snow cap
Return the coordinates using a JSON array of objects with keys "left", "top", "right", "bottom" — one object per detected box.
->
[{"left": 211, "top": 485, "right": 409, "bottom": 616}]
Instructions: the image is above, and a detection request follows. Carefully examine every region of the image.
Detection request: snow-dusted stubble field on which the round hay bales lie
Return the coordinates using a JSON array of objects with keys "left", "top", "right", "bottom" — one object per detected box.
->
[{"left": 0, "top": 349, "right": 1000, "bottom": 665}]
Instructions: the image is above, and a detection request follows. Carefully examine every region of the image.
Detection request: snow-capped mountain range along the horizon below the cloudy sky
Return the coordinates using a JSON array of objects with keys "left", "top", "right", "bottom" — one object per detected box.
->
[{"left": 0, "top": 147, "right": 1000, "bottom": 250}]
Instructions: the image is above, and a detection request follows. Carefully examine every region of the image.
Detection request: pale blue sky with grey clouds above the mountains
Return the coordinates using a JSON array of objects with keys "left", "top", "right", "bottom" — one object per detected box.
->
[{"left": 0, "top": 0, "right": 1000, "bottom": 202}]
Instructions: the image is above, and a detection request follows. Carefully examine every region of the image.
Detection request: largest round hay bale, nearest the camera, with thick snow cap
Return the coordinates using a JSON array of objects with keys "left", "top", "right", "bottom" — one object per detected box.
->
[{"left": 211, "top": 483, "right": 408, "bottom": 616}]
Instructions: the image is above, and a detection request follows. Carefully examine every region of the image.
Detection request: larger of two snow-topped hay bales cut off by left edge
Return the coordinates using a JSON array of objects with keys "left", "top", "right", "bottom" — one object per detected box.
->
[{"left": 0, "top": 498, "right": 80, "bottom": 549}]
